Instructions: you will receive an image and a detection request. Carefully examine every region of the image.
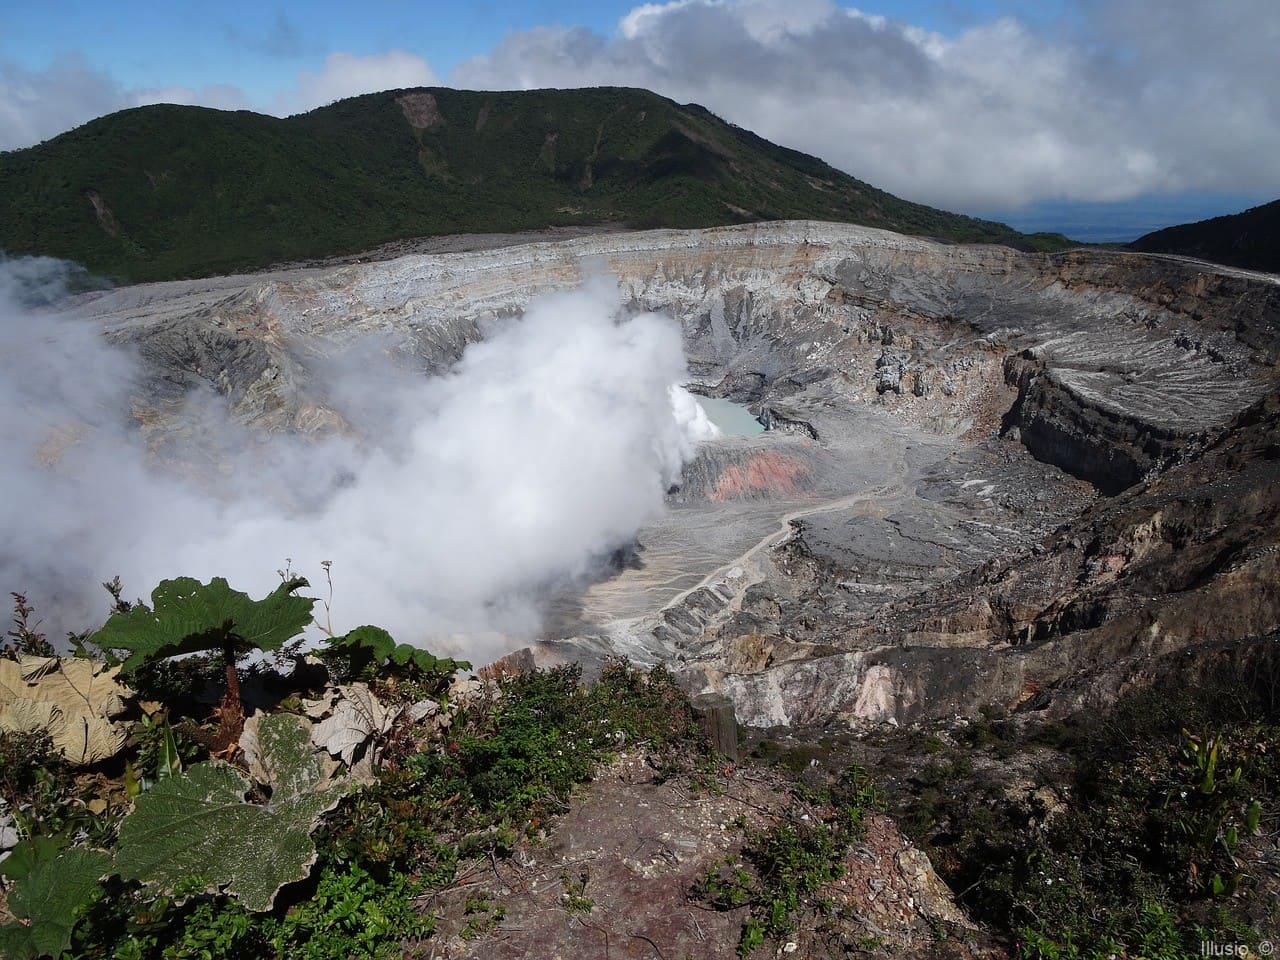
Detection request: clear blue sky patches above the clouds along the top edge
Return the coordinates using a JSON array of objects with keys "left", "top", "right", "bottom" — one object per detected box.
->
[{"left": 0, "top": 0, "right": 1069, "bottom": 90}]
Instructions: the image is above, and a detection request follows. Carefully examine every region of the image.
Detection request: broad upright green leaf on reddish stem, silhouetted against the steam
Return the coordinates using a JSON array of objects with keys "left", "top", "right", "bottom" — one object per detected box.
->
[{"left": 91, "top": 577, "right": 315, "bottom": 673}]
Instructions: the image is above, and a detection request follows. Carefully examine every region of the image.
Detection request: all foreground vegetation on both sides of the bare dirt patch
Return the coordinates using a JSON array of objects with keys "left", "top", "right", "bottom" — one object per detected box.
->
[{"left": 0, "top": 581, "right": 1280, "bottom": 960}]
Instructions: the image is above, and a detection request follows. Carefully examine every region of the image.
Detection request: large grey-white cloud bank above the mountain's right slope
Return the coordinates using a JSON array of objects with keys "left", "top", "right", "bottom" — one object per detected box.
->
[{"left": 452, "top": 0, "right": 1280, "bottom": 210}]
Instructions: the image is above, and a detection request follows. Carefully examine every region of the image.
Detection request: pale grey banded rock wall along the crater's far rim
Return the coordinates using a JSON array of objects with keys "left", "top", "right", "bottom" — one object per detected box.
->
[{"left": 86, "top": 223, "right": 1280, "bottom": 492}]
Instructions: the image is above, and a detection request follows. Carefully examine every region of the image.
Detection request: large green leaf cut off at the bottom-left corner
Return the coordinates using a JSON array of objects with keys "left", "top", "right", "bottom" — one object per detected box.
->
[{"left": 0, "top": 837, "right": 111, "bottom": 960}]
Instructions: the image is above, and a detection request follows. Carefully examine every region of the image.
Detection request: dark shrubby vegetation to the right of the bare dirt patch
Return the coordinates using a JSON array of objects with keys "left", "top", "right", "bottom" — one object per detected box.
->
[{"left": 877, "top": 655, "right": 1280, "bottom": 960}]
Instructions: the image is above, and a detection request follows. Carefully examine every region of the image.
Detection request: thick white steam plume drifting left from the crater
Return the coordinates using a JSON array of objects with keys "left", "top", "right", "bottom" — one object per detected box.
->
[{"left": 0, "top": 260, "right": 714, "bottom": 657}]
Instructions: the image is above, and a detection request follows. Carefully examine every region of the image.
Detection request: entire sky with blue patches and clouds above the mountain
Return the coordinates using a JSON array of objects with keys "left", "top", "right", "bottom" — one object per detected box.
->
[{"left": 0, "top": 0, "right": 1280, "bottom": 239}]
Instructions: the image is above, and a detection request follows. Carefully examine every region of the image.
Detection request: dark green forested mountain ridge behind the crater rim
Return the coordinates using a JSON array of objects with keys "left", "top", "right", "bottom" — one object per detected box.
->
[{"left": 0, "top": 87, "right": 1066, "bottom": 280}]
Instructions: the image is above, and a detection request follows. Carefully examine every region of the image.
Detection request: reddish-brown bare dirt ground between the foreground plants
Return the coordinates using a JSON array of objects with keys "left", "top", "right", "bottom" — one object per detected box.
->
[{"left": 424, "top": 754, "right": 1000, "bottom": 960}]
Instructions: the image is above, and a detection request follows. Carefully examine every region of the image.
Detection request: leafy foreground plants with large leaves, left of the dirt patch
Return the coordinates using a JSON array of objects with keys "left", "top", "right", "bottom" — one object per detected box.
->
[{"left": 0, "top": 579, "right": 713, "bottom": 960}]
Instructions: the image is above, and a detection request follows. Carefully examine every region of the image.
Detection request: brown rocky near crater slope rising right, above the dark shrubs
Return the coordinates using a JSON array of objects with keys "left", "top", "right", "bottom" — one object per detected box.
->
[{"left": 699, "top": 394, "right": 1280, "bottom": 726}]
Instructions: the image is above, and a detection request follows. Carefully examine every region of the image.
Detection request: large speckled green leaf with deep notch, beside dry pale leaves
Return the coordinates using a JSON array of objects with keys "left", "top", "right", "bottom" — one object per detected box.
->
[{"left": 115, "top": 713, "right": 346, "bottom": 910}]
